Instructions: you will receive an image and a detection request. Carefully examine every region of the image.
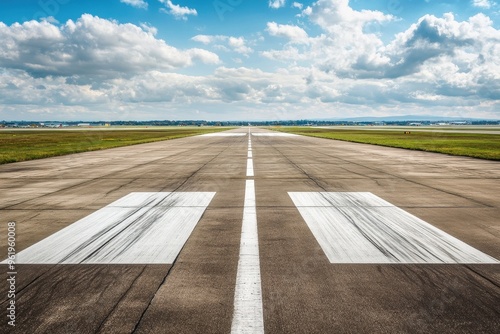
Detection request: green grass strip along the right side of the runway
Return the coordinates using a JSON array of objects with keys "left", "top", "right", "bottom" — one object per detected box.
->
[{"left": 272, "top": 127, "right": 500, "bottom": 160}]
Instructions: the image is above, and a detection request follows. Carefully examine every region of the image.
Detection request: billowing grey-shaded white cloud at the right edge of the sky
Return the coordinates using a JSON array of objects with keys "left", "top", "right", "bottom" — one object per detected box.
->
[{"left": 385, "top": 13, "right": 500, "bottom": 81}]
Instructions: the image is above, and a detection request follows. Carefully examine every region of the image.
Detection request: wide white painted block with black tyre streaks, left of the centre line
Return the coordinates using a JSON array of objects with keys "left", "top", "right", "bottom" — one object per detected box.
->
[{"left": 10, "top": 192, "right": 215, "bottom": 264}]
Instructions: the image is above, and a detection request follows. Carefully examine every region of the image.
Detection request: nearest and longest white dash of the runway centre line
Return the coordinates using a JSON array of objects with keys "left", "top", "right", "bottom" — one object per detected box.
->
[{"left": 231, "top": 180, "right": 264, "bottom": 334}]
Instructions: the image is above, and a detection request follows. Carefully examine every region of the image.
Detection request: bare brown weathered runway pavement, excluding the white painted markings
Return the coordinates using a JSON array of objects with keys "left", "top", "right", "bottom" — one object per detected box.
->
[{"left": 0, "top": 129, "right": 500, "bottom": 333}]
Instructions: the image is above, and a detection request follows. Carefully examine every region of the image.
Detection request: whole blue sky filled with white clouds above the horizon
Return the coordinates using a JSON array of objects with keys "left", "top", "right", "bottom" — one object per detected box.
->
[{"left": 0, "top": 0, "right": 500, "bottom": 121}]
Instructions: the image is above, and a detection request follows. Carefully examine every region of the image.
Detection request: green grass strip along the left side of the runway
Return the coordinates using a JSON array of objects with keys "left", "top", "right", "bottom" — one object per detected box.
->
[{"left": 0, "top": 127, "right": 229, "bottom": 164}]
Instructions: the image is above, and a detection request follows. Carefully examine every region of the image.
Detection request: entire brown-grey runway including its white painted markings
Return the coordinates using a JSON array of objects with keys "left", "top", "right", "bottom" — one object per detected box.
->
[{"left": 0, "top": 128, "right": 500, "bottom": 333}]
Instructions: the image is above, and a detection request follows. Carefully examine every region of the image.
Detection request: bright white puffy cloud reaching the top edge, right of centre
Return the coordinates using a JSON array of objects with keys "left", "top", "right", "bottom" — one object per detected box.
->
[{"left": 268, "top": 0, "right": 394, "bottom": 76}]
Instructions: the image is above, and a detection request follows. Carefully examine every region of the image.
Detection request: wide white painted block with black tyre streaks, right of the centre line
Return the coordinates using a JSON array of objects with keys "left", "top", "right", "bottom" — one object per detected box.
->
[{"left": 289, "top": 192, "right": 500, "bottom": 263}]
